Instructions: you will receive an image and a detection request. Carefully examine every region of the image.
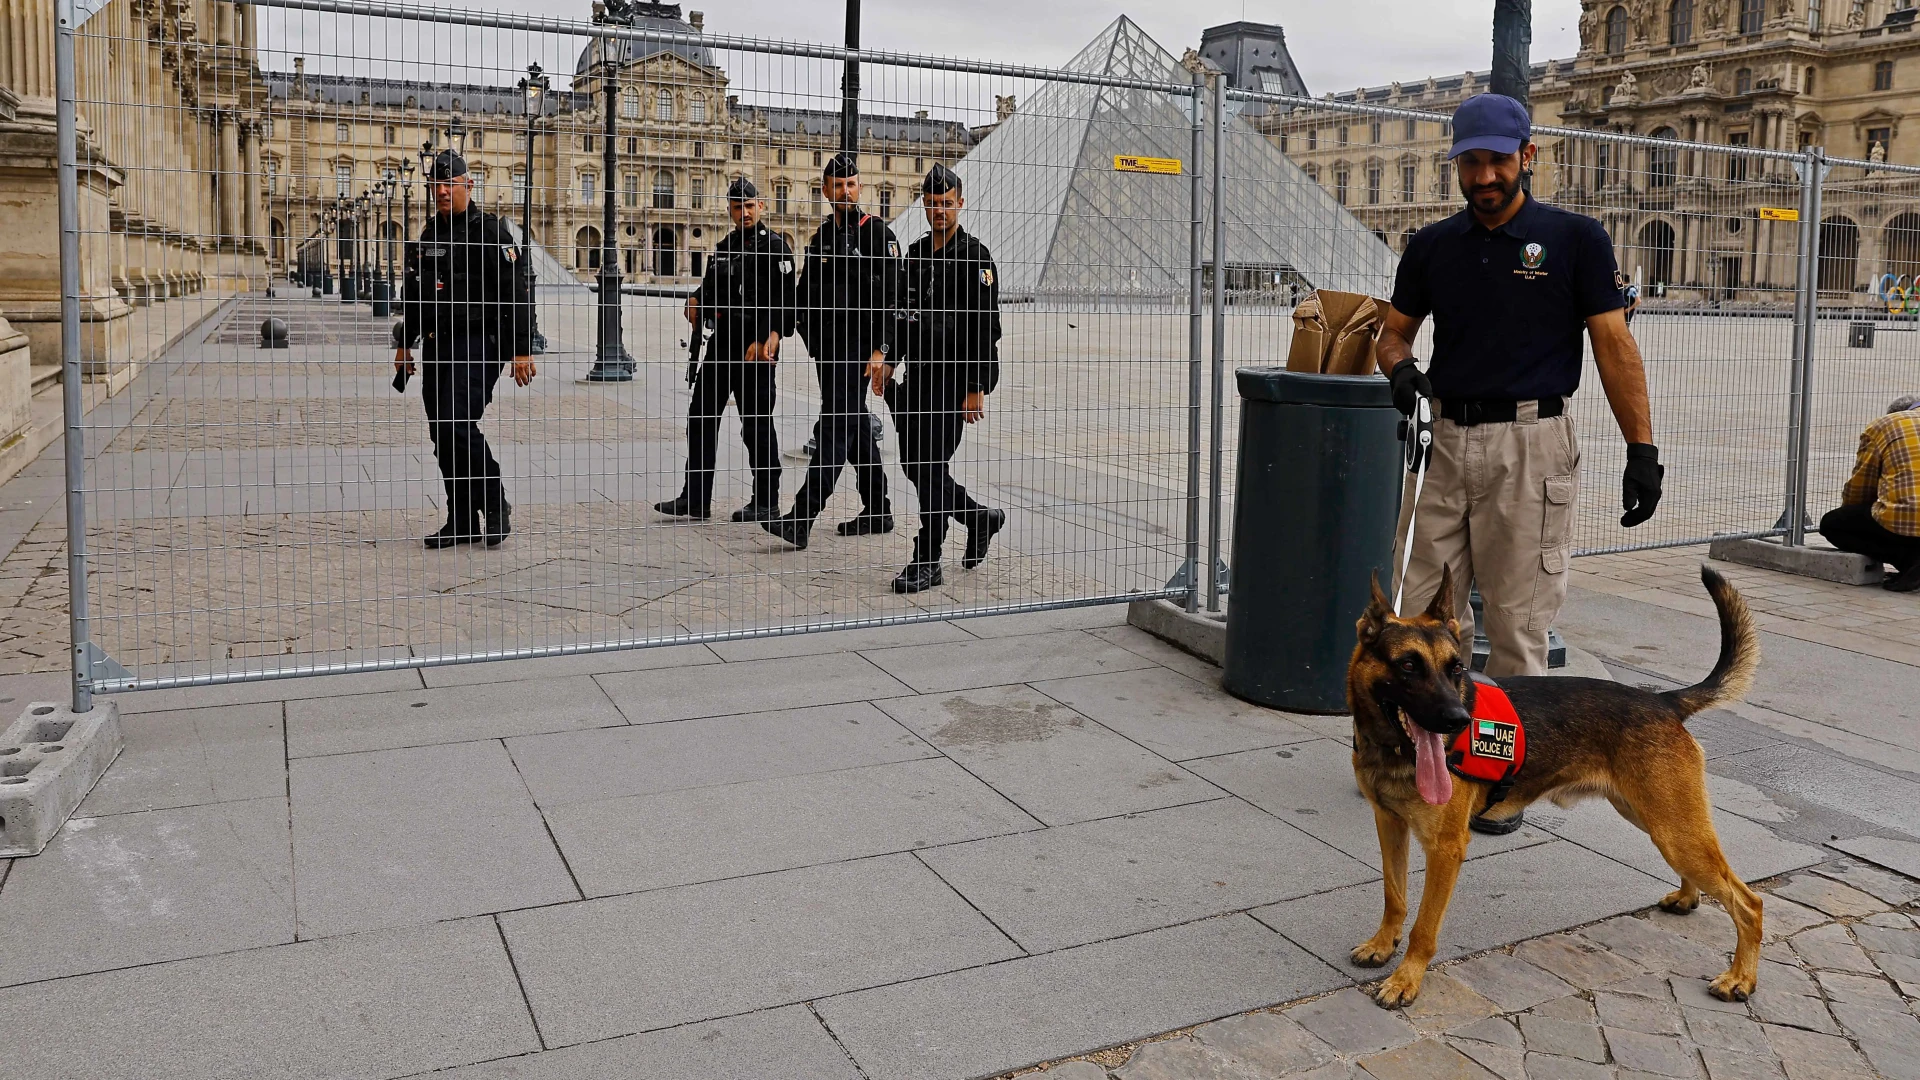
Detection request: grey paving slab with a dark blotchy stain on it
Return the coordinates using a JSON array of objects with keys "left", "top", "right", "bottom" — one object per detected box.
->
[{"left": 879, "top": 686, "right": 1219, "bottom": 824}]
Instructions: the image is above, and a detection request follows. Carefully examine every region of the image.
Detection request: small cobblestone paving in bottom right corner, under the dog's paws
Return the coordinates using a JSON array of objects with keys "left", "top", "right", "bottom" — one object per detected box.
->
[{"left": 1006, "top": 857, "right": 1920, "bottom": 1080}]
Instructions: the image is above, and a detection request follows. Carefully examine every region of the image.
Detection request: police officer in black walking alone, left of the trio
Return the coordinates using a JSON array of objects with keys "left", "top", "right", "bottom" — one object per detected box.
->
[{"left": 394, "top": 150, "right": 534, "bottom": 550}]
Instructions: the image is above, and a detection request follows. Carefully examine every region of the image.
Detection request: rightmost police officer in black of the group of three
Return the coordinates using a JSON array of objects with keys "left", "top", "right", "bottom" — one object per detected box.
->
[{"left": 868, "top": 165, "right": 1006, "bottom": 592}]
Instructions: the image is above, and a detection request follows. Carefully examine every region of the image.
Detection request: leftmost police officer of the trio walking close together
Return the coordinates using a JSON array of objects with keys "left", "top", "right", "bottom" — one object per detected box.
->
[{"left": 653, "top": 177, "right": 793, "bottom": 521}]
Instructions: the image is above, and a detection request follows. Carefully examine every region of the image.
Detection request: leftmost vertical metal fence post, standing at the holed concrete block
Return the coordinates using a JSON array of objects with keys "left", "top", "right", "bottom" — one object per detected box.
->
[{"left": 54, "top": 0, "right": 94, "bottom": 713}]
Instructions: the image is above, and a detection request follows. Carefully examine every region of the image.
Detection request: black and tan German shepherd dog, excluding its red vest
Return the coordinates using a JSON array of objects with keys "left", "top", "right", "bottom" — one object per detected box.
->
[{"left": 1346, "top": 567, "right": 1761, "bottom": 1007}]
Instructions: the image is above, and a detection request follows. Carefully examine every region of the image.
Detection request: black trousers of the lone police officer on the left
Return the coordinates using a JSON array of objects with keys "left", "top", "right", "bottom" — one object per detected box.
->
[{"left": 420, "top": 334, "right": 507, "bottom": 532}]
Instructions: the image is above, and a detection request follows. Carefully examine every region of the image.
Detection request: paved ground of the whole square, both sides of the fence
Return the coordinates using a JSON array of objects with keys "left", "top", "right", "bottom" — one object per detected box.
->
[{"left": 0, "top": 290, "right": 1920, "bottom": 1080}]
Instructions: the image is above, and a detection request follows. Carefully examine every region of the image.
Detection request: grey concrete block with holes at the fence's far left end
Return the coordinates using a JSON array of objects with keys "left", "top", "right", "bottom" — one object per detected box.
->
[{"left": 0, "top": 701, "right": 121, "bottom": 857}]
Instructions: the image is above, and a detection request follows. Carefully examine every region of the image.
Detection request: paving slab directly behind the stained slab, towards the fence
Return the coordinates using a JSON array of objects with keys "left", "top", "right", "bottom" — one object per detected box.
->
[{"left": 862, "top": 630, "right": 1154, "bottom": 694}]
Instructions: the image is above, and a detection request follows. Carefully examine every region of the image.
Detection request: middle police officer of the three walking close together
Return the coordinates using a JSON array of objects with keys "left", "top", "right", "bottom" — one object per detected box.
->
[{"left": 760, "top": 152, "right": 900, "bottom": 548}]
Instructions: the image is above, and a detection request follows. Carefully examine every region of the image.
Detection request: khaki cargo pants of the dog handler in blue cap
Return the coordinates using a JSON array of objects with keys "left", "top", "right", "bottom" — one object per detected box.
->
[{"left": 1394, "top": 402, "right": 1580, "bottom": 678}]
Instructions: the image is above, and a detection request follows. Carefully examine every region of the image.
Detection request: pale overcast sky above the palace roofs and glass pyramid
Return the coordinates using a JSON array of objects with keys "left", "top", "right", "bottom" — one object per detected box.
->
[{"left": 263, "top": 0, "right": 1580, "bottom": 96}]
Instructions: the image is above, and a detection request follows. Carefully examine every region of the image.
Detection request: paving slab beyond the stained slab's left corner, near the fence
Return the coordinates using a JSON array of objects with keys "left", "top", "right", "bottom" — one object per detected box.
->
[{"left": 595, "top": 641, "right": 912, "bottom": 724}]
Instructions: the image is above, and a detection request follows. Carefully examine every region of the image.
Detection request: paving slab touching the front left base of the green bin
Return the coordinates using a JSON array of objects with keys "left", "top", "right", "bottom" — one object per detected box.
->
[{"left": 1035, "top": 667, "right": 1328, "bottom": 771}]
